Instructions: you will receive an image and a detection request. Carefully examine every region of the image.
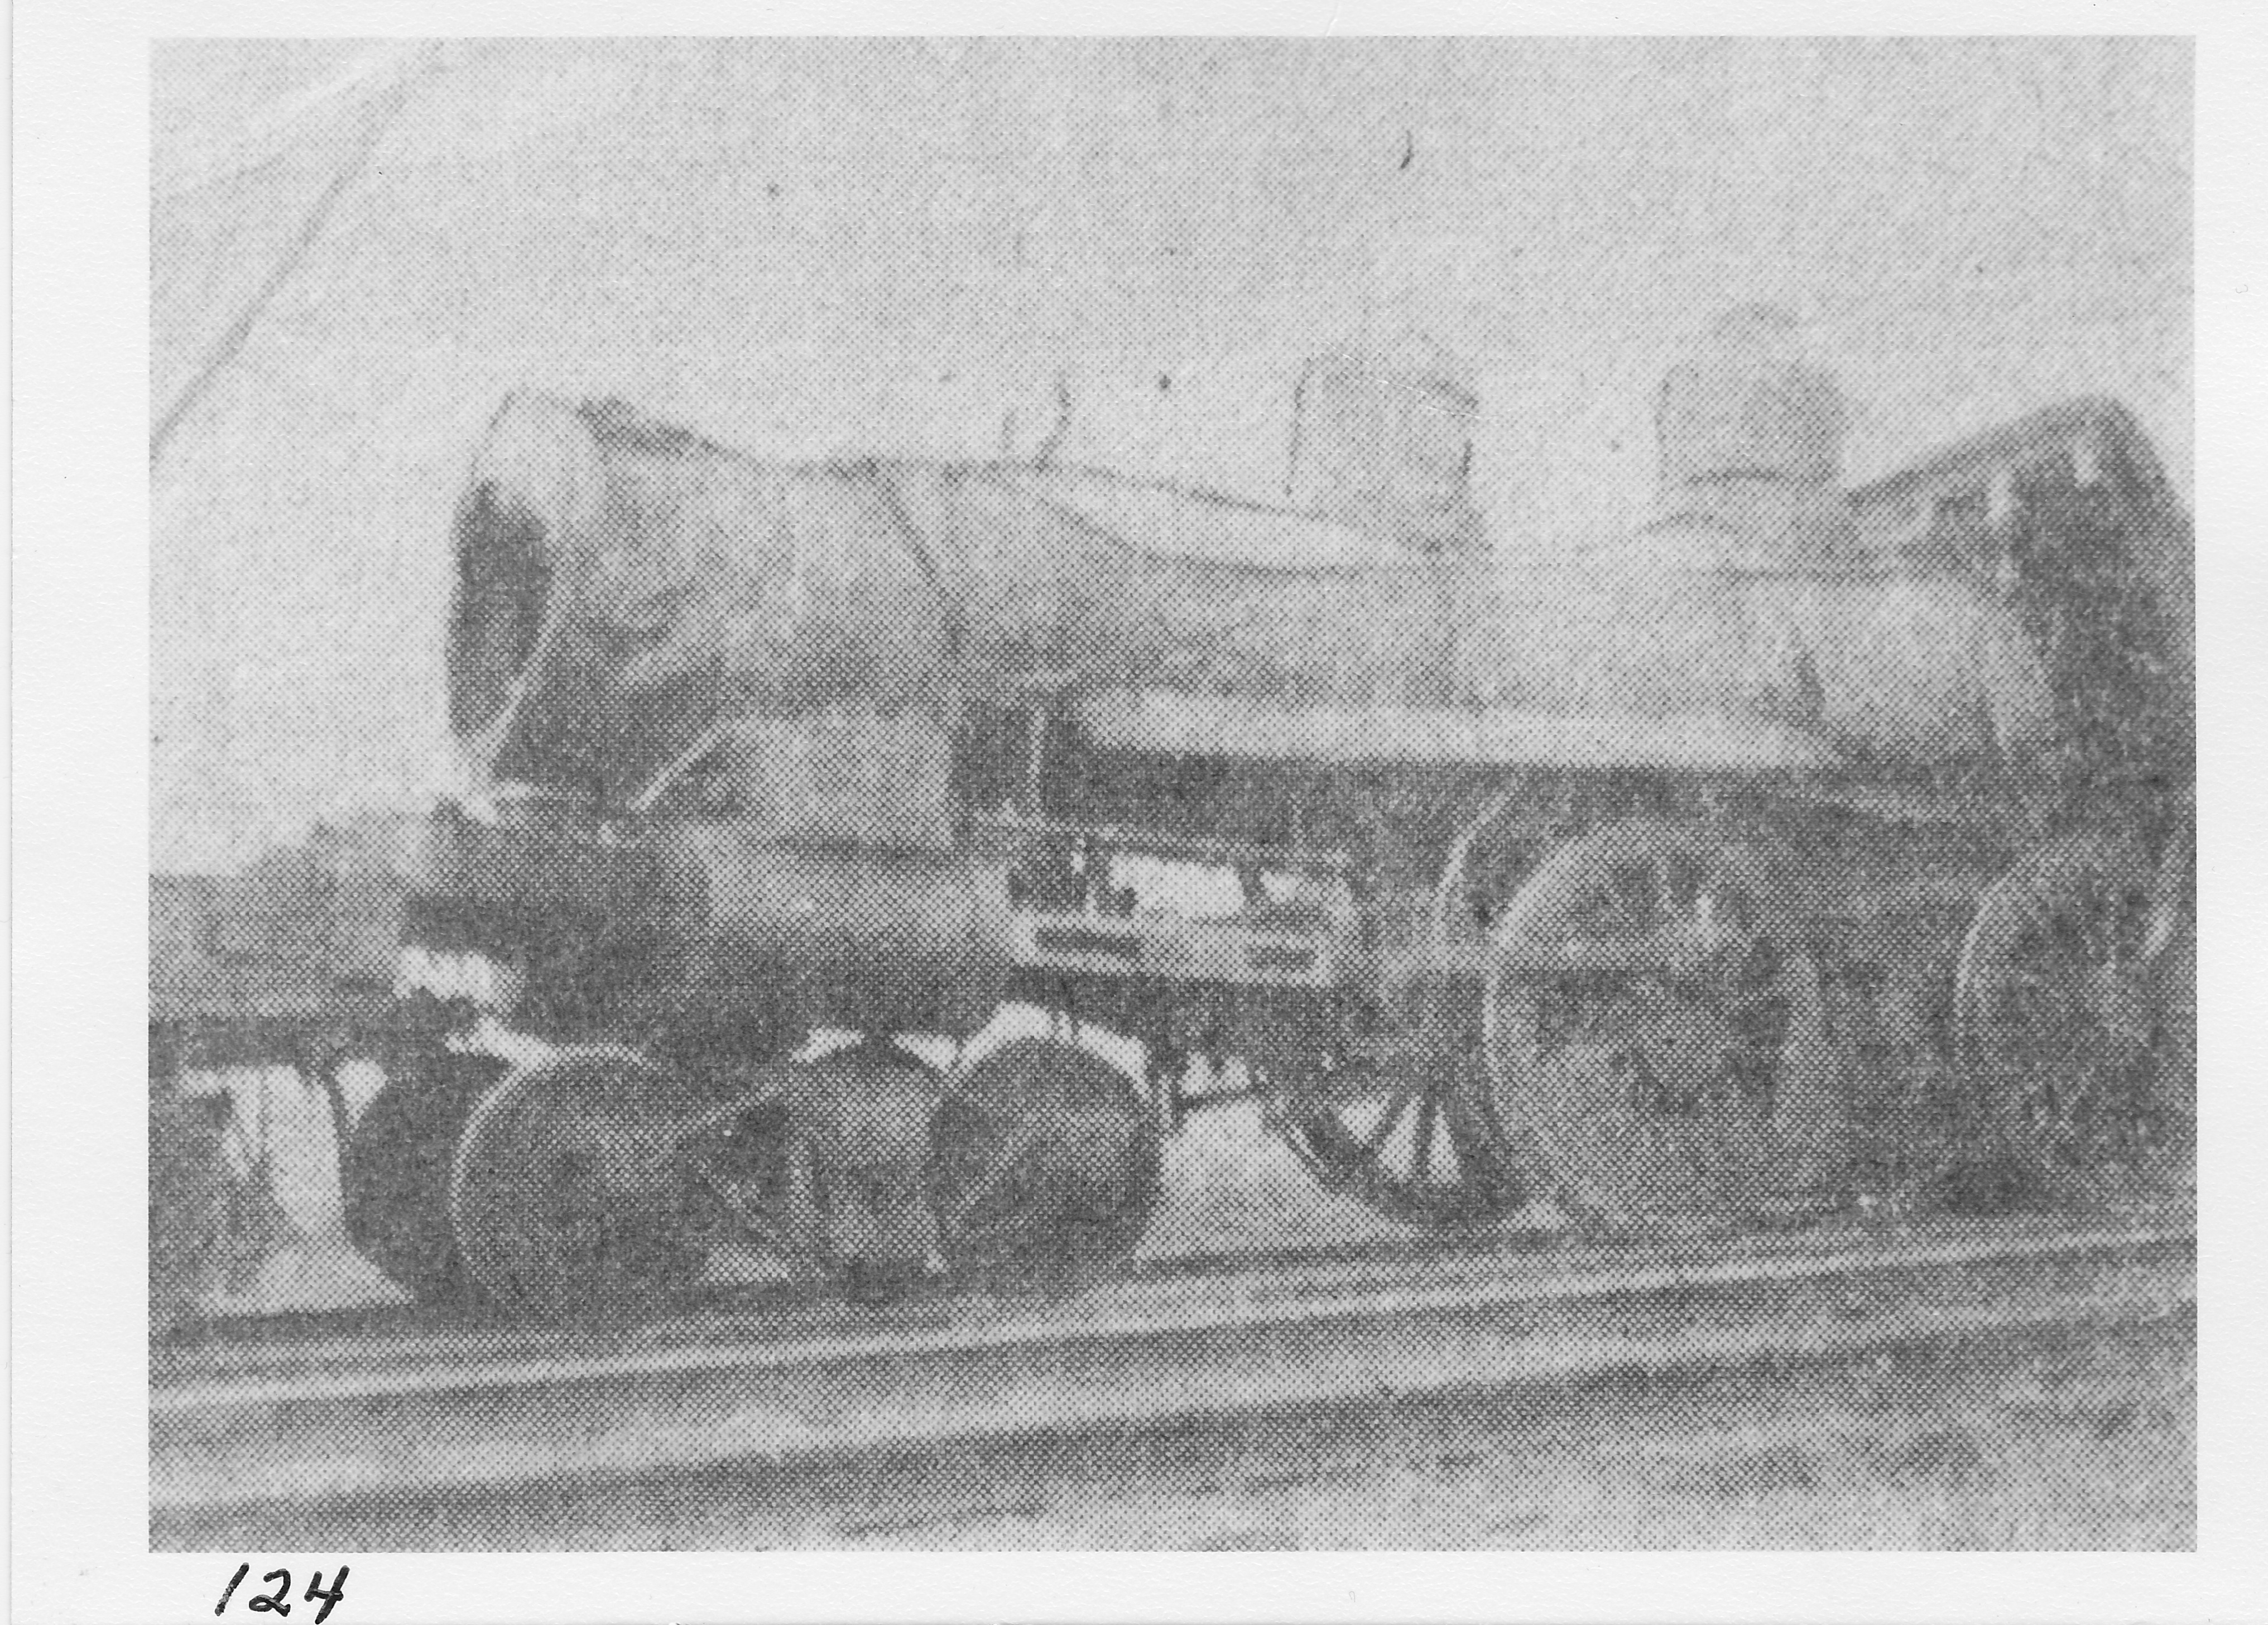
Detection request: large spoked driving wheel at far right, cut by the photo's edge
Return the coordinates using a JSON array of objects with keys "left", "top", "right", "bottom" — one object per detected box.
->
[{"left": 1955, "top": 834, "right": 2195, "bottom": 1190}]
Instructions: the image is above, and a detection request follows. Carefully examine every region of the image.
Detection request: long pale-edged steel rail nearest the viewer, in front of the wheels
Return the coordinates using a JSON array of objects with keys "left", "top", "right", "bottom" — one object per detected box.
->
[{"left": 150, "top": 1228, "right": 2195, "bottom": 1544}]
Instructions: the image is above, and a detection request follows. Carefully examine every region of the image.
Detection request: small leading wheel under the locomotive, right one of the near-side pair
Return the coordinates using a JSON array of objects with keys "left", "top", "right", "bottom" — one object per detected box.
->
[{"left": 928, "top": 1038, "right": 1161, "bottom": 1281}]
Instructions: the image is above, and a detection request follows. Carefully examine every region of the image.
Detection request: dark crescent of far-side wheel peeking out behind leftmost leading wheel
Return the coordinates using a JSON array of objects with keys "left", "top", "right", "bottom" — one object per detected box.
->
[{"left": 338, "top": 1049, "right": 508, "bottom": 1303}]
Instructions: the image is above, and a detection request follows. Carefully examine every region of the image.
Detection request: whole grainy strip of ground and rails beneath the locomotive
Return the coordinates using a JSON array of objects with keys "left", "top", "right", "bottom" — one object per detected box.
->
[{"left": 152, "top": 1224, "right": 2195, "bottom": 1550}]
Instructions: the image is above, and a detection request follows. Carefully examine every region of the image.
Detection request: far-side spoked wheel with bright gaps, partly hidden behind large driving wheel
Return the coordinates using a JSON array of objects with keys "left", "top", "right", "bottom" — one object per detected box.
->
[{"left": 1275, "top": 983, "right": 1522, "bottom": 1230}]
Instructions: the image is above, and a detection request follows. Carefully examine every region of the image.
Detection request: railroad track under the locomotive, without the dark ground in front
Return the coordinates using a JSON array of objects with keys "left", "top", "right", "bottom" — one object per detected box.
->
[{"left": 150, "top": 1219, "right": 2195, "bottom": 1550}]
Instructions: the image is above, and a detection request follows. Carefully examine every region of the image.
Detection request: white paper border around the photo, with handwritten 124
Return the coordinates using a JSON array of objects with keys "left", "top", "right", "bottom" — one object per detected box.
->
[{"left": 11, "top": 0, "right": 2268, "bottom": 1625}]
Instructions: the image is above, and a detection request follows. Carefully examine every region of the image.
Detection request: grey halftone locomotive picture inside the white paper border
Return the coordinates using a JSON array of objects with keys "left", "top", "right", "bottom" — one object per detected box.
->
[{"left": 132, "top": 36, "right": 2198, "bottom": 1559}]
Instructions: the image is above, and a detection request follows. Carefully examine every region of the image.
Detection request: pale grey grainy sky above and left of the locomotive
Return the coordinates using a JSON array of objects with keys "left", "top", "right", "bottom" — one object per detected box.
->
[{"left": 152, "top": 39, "right": 2191, "bottom": 866}]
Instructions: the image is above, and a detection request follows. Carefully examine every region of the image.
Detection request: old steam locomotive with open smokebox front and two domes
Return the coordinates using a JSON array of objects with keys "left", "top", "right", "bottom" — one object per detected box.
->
[{"left": 347, "top": 315, "right": 2195, "bottom": 1315}]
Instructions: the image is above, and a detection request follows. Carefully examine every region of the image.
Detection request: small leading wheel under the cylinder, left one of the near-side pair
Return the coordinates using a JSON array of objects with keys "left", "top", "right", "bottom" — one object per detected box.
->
[{"left": 449, "top": 1047, "right": 705, "bottom": 1319}]
